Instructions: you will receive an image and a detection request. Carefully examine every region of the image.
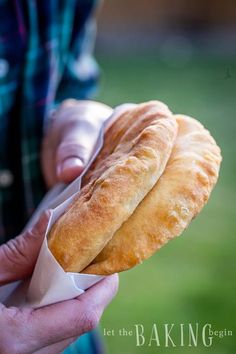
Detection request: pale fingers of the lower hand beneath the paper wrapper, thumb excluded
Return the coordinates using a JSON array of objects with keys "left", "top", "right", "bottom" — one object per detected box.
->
[{"left": 0, "top": 274, "right": 118, "bottom": 354}]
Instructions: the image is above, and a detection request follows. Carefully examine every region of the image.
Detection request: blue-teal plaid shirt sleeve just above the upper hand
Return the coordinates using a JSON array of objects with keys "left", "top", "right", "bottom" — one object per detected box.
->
[{"left": 54, "top": 3, "right": 99, "bottom": 108}]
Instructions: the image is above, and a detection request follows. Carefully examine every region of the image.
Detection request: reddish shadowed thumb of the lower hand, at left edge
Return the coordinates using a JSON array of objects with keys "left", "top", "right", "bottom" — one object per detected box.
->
[{"left": 0, "top": 211, "right": 51, "bottom": 285}]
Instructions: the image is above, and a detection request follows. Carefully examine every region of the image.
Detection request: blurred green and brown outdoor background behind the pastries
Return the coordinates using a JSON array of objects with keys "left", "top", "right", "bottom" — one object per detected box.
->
[{"left": 94, "top": 0, "right": 236, "bottom": 354}]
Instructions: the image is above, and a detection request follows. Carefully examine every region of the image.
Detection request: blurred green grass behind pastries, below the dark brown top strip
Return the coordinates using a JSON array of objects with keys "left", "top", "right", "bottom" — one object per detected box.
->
[{"left": 95, "top": 53, "right": 236, "bottom": 354}]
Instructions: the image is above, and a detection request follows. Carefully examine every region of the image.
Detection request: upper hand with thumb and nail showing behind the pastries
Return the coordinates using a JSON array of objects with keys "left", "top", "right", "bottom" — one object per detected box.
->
[{"left": 41, "top": 99, "right": 112, "bottom": 187}]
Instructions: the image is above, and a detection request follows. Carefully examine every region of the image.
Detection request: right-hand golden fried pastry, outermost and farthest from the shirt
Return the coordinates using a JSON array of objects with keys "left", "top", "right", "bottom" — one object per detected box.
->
[{"left": 82, "top": 115, "right": 221, "bottom": 274}]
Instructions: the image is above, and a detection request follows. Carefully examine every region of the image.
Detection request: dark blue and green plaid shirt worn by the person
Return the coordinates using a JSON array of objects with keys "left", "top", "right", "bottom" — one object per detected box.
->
[{"left": 0, "top": 0, "right": 98, "bottom": 244}]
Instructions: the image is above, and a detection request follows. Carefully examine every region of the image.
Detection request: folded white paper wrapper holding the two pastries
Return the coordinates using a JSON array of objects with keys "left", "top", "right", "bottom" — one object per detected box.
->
[{"left": 0, "top": 109, "right": 113, "bottom": 308}]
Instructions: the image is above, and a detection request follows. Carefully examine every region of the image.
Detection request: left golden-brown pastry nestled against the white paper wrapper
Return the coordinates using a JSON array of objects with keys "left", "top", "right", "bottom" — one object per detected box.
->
[{"left": 48, "top": 101, "right": 177, "bottom": 274}]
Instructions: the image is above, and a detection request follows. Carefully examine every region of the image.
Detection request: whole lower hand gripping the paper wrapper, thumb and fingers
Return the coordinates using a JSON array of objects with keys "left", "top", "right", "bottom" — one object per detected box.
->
[{"left": 0, "top": 212, "right": 118, "bottom": 354}]
